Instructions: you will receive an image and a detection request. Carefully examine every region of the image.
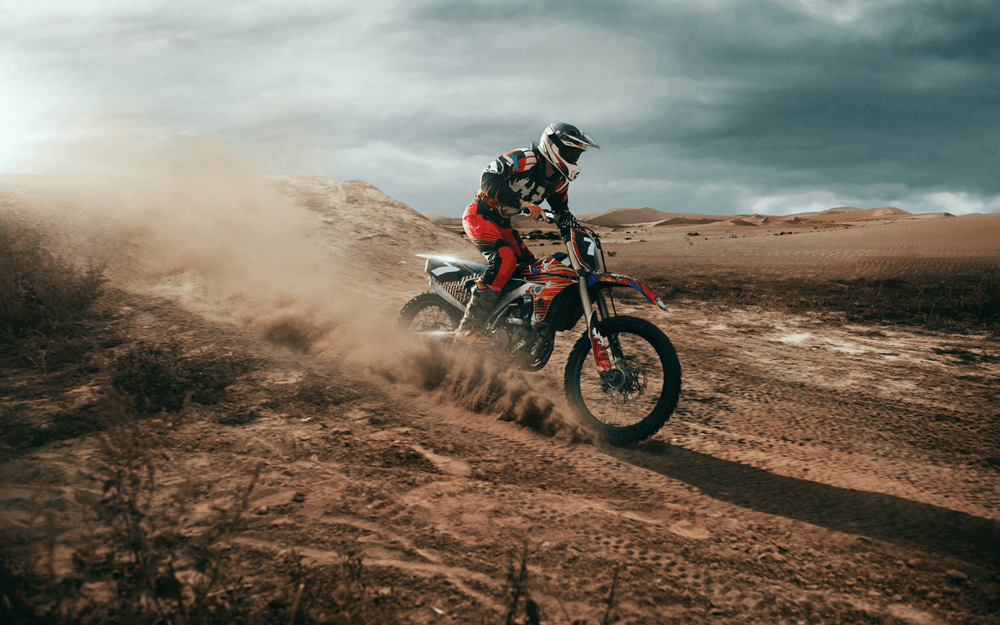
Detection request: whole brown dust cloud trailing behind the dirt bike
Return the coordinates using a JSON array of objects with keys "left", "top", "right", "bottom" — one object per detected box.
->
[{"left": 0, "top": 131, "right": 585, "bottom": 440}]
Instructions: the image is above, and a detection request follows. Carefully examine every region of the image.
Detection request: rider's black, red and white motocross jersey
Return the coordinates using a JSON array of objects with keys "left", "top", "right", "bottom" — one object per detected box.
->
[{"left": 476, "top": 144, "right": 569, "bottom": 228}]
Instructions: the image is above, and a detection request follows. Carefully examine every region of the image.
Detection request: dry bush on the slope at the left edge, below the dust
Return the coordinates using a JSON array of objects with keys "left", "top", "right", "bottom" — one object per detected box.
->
[{"left": 0, "top": 214, "right": 106, "bottom": 369}]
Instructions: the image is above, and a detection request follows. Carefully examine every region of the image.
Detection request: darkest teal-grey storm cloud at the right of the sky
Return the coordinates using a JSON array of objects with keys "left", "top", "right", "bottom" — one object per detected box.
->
[{"left": 663, "top": 5, "right": 1000, "bottom": 193}]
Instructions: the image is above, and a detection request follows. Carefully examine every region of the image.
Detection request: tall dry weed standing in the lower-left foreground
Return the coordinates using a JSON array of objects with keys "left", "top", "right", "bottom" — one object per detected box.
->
[{"left": 84, "top": 393, "right": 260, "bottom": 622}]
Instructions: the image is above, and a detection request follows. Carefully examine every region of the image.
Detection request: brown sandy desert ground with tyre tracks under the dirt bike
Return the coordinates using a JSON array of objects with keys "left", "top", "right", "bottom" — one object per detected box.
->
[{"left": 0, "top": 172, "right": 1000, "bottom": 625}]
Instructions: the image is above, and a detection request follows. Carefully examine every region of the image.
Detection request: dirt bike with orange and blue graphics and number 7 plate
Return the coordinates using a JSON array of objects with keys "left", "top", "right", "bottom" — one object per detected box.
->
[{"left": 397, "top": 211, "right": 681, "bottom": 445}]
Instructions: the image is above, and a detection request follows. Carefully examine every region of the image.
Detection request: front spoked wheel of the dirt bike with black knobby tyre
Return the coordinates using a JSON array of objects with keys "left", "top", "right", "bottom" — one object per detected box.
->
[{"left": 565, "top": 317, "right": 681, "bottom": 445}]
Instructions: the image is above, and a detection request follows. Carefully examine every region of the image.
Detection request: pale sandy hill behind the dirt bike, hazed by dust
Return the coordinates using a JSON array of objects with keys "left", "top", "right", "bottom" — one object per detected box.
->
[{"left": 0, "top": 174, "right": 482, "bottom": 297}]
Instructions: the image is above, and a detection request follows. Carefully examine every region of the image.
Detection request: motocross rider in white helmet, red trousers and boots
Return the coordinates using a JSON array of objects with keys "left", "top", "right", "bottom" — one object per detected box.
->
[{"left": 455, "top": 123, "right": 600, "bottom": 345}]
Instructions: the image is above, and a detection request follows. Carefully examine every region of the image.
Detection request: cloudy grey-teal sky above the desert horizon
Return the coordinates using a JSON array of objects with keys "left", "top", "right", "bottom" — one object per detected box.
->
[{"left": 0, "top": 0, "right": 1000, "bottom": 215}]
